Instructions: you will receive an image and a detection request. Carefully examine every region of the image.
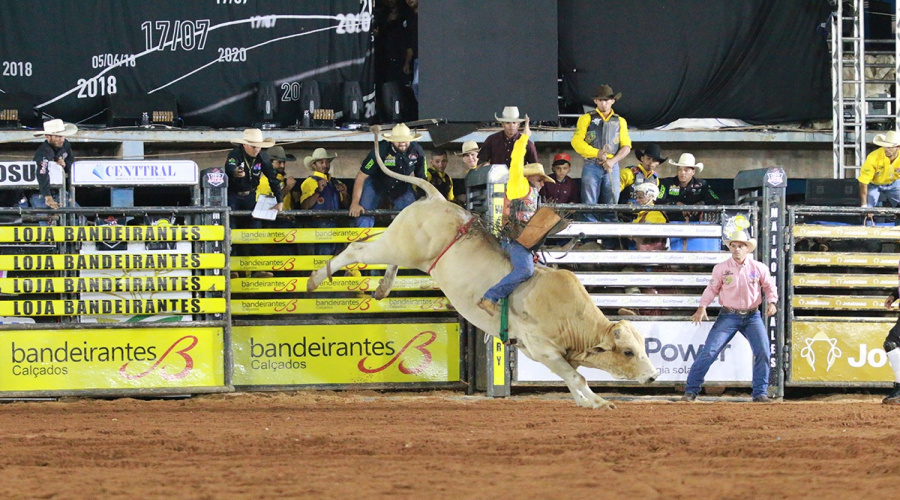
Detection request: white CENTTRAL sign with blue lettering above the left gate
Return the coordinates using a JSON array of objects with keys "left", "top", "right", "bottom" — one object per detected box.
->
[{"left": 72, "top": 160, "right": 199, "bottom": 186}]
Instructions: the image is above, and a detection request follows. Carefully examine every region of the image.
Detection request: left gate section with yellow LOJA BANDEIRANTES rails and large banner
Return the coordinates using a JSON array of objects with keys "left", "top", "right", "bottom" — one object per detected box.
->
[{"left": 0, "top": 207, "right": 233, "bottom": 398}]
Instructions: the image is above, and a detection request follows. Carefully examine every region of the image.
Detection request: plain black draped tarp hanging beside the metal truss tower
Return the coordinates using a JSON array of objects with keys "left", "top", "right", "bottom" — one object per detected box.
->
[{"left": 558, "top": 0, "right": 831, "bottom": 128}]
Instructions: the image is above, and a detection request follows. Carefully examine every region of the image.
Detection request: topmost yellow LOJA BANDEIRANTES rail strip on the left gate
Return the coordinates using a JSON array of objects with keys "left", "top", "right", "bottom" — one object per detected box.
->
[{"left": 0, "top": 225, "right": 225, "bottom": 243}]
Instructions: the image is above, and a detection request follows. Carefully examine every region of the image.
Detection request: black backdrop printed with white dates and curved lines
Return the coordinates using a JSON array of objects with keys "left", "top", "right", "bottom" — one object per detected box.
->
[{"left": 0, "top": 0, "right": 374, "bottom": 127}]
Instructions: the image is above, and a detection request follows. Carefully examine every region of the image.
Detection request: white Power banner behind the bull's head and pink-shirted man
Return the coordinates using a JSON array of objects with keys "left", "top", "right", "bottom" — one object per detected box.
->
[{"left": 516, "top": 321, "right": 753, "bottom": 382}]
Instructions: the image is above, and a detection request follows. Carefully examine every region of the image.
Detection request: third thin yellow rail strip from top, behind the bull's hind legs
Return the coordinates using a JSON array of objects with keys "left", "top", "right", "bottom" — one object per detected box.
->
[{"left": 230, "top": 276, "right": 439, "bottom": 293}]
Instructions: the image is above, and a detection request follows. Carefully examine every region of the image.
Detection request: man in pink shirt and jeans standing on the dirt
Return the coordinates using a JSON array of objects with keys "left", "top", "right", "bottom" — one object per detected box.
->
[{"left": 681, "top": 230, "right": 778, "bottom": 403}]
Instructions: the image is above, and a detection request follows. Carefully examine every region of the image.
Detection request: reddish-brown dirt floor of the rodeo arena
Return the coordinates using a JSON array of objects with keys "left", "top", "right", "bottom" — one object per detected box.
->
[{"left": 0, "top": 391, "right": 900, "bottom": 500}]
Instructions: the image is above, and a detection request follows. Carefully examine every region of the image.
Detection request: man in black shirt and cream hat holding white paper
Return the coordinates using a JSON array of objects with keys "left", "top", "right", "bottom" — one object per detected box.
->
[{"left": 225, "top": 128, "right": 284, "bottom": 278}]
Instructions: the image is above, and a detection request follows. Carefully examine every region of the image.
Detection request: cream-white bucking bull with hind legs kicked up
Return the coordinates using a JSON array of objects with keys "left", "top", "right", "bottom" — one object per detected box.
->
[{"left": 307, "top": 127, "right": 657, "bottom": 408}]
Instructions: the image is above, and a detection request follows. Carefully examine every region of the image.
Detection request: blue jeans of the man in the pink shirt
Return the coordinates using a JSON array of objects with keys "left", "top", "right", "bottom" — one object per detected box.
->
[{"left": 684, "top": 311, "right": 769, "bottom": 397}]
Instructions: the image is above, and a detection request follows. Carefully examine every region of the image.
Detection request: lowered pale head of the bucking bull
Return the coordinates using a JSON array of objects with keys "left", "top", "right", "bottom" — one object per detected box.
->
[{"left": 572, "top": 320, "right": 658, "bottom": 384}]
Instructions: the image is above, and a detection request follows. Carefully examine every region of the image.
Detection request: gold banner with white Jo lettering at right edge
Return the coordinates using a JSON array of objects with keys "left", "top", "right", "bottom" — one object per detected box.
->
[{"left": 791, "top": 321, "right": 894, "bottom": 382}]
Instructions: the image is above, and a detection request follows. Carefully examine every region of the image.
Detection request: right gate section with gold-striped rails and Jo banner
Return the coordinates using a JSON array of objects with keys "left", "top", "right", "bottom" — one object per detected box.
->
[{"left": 786, "top": 207, "right": 900, "bottom": 387}]
